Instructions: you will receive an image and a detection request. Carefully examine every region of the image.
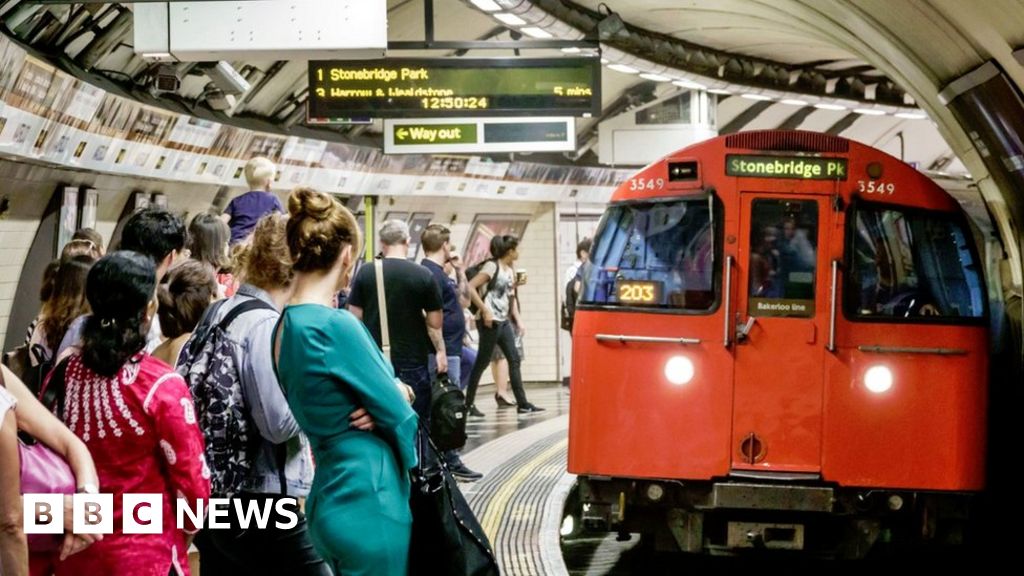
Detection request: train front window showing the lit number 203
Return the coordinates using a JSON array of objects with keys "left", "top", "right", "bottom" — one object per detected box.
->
[{"left": 580, "top": 198, "right": 716, "bottom": 312}]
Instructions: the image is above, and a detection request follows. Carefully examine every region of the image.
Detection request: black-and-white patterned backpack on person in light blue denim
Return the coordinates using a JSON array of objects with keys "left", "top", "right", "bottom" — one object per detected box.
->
[{"left": 176, "top": 298, "right": 274, "bottom": 496}]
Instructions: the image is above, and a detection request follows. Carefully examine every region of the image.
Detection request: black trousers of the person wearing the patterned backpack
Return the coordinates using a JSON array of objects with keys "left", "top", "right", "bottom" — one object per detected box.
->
[{"left": 196, "top": 494, "right": 331, "bottom": 576}]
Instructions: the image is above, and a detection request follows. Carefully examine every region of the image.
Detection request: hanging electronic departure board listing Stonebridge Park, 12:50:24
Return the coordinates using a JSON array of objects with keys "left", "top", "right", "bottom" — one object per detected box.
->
[{"left": 308, "top": 57, "right": 601, "bottom": 123}]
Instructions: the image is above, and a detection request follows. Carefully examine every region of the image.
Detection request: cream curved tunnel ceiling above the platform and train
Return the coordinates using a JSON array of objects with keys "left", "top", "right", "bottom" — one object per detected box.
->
[{"left": 0, "top": 0, "right": 1024, "bottom": 228}]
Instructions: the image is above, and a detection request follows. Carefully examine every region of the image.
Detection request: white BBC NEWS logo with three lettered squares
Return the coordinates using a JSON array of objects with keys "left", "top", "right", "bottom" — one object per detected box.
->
[{"left": 23, "top": 494, "right": 299, "bottom": 534}]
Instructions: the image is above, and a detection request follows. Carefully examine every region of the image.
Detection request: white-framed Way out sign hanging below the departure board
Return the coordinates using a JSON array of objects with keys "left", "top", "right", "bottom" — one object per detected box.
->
[{"left": 384, "top": 118, "right": 575, "bottom": 154}]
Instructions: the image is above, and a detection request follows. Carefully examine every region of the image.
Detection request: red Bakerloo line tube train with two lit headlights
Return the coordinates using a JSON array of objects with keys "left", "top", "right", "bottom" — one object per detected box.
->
[{"left": 568, "top": 131, "right": 988, "bottom": 558}]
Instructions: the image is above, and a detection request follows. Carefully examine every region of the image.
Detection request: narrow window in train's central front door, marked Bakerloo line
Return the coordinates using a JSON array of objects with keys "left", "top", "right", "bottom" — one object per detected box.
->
[{"left": 748, "top": 199, "right": 818, "bottom": 318}]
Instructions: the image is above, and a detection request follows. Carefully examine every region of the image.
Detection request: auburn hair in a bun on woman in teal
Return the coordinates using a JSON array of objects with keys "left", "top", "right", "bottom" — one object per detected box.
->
[{"left": 287, "top": 188, "right": 360, "bottom": 272}]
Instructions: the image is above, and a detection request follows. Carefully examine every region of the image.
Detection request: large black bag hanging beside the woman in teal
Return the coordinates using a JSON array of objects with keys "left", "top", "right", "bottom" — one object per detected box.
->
[{"left": 409, "top": 425, "right": 499, "bottom": 576}]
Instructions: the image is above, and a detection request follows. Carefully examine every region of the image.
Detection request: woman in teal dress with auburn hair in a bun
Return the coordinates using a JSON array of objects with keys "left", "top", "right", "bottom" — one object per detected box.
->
[{"left": 274, "top": 189, "right": 417, "bottom": 576}]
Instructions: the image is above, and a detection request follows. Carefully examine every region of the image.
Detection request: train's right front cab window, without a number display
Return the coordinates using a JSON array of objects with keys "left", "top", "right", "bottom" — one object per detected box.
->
[{"left": 845, "top": 206, "right": 985, "bottom": 321}]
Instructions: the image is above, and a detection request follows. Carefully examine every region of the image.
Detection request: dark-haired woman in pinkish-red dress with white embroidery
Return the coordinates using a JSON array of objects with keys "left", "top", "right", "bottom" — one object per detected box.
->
[{"left": 47, "top": 251, "right": 210, "bottom": 576}]
